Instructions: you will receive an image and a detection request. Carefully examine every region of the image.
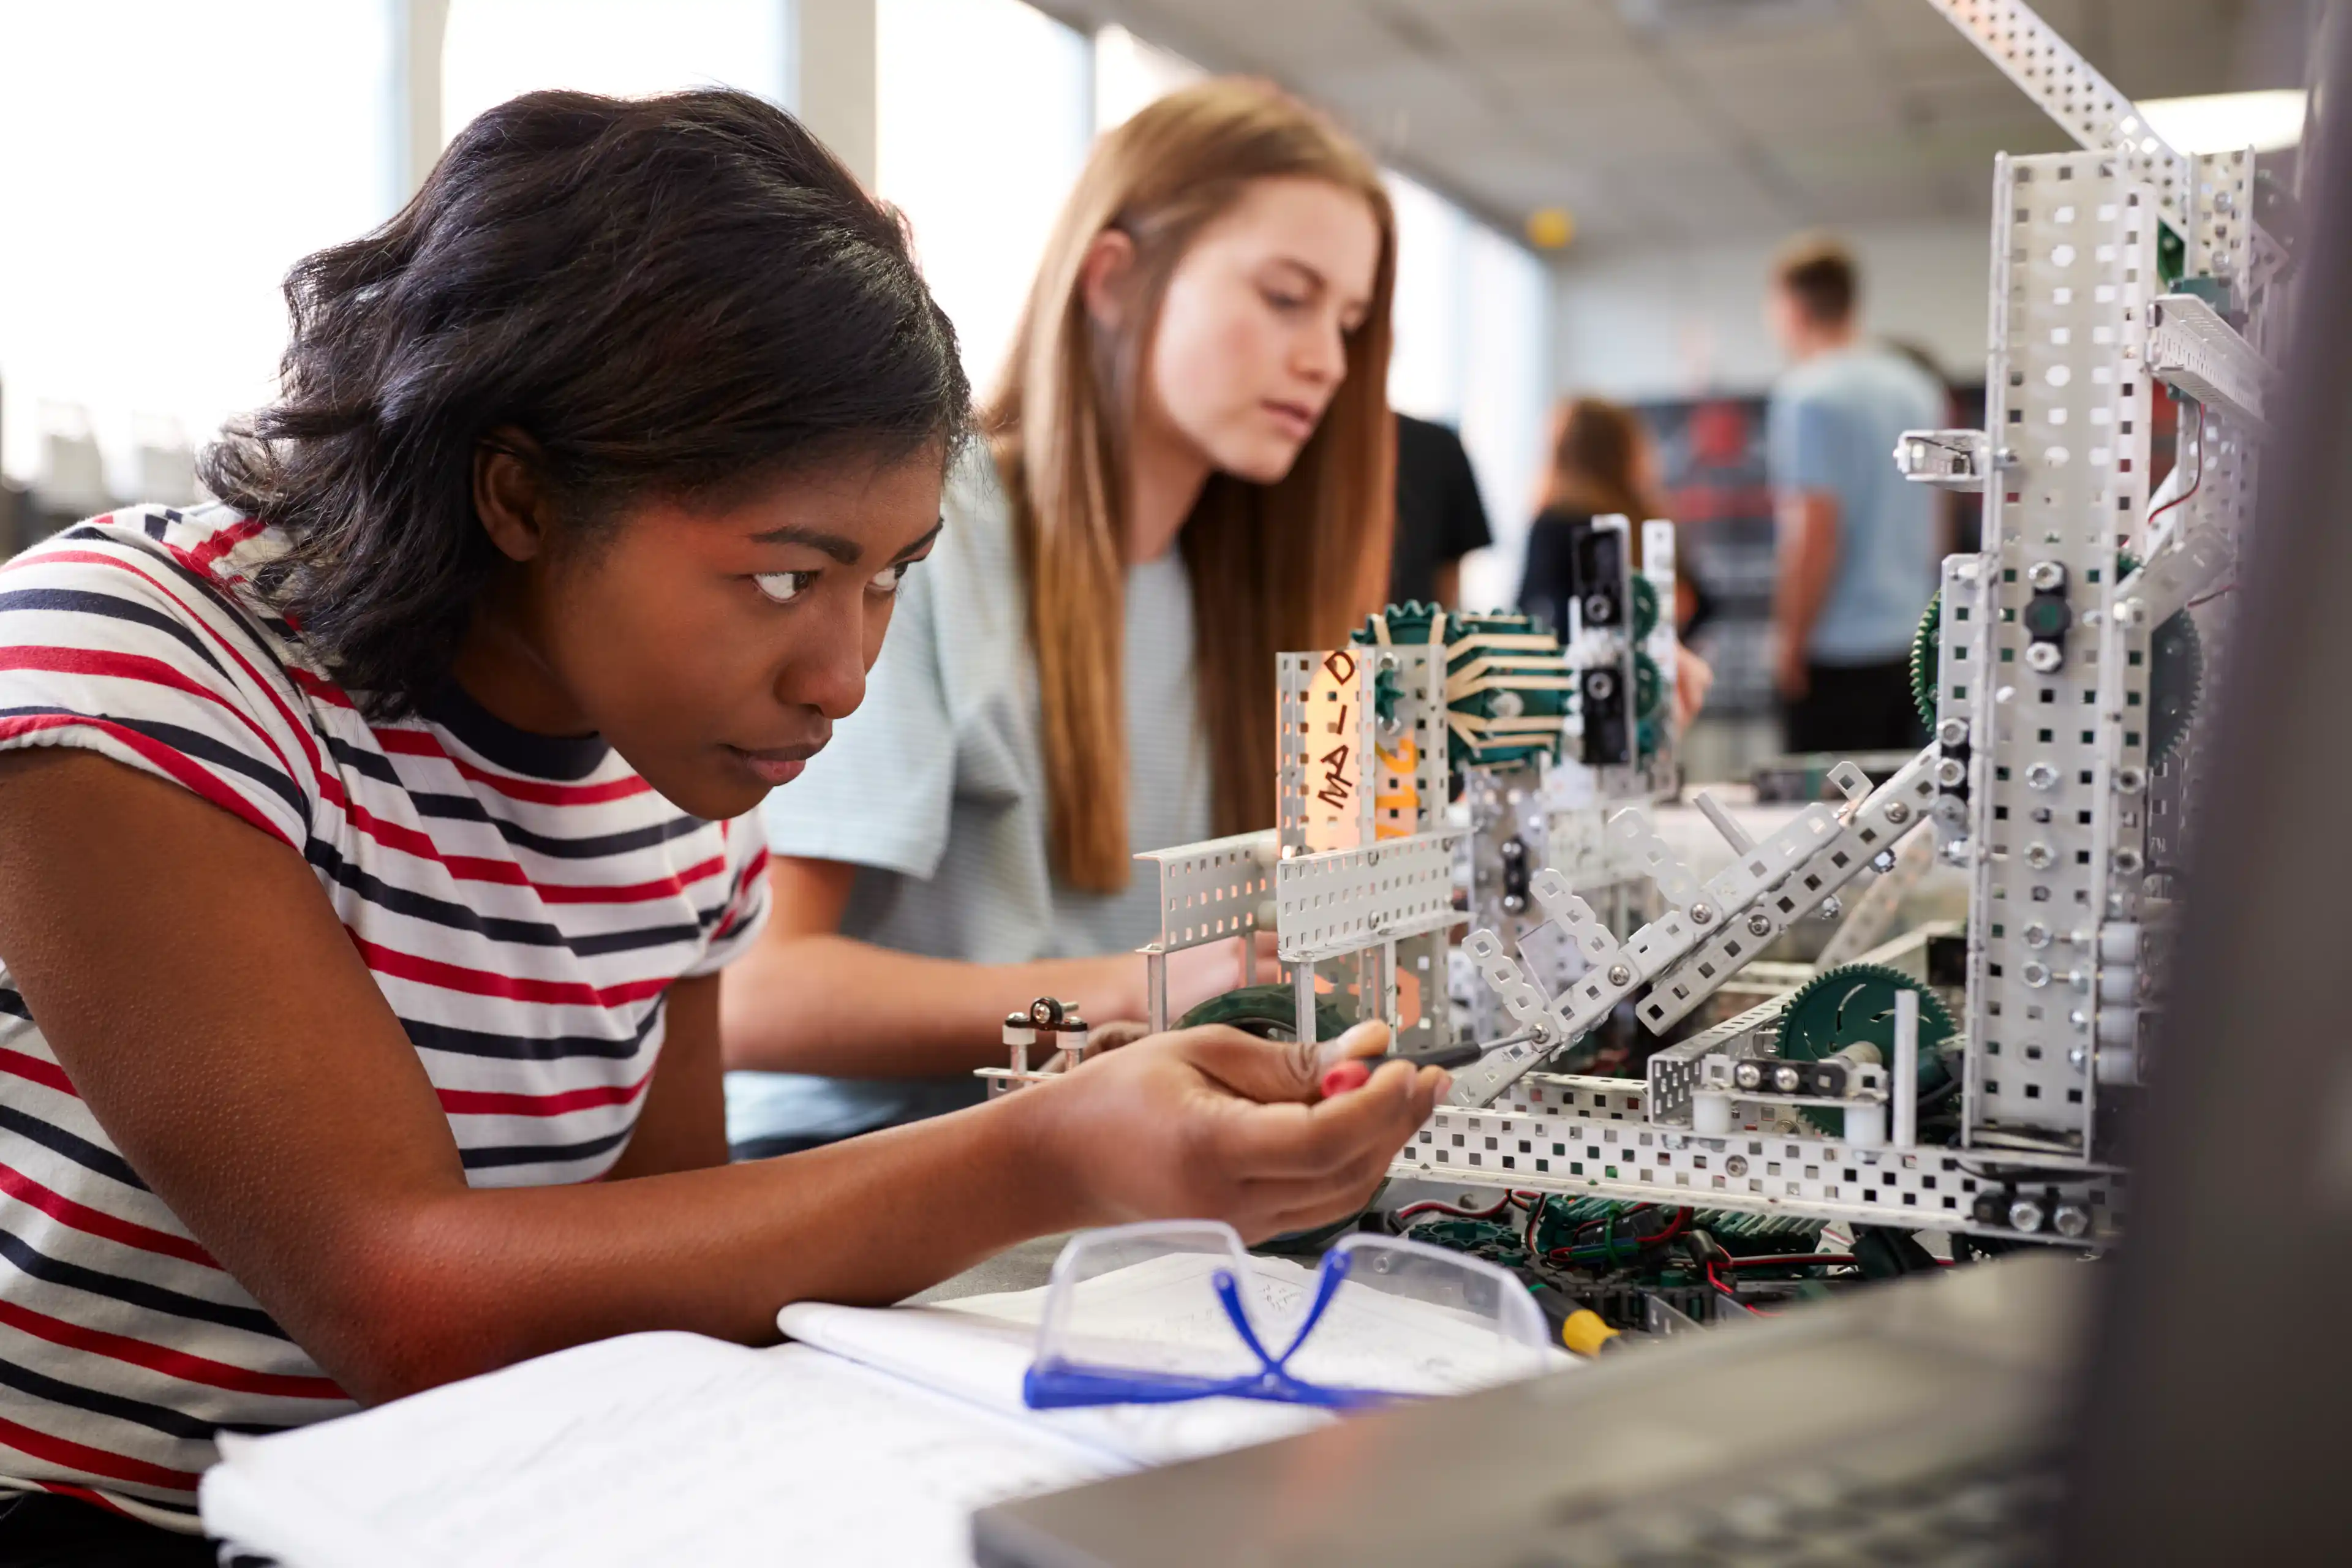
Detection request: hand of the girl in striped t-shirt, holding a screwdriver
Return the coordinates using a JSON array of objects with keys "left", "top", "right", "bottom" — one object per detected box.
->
[{"left": 1016, "top": 1023, "right": 1449, "bottom": 1242}]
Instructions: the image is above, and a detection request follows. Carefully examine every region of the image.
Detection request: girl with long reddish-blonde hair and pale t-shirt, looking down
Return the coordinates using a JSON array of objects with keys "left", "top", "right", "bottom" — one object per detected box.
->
[{"left": 725, "top": 80, "right": 1397, "bottom": 1154}]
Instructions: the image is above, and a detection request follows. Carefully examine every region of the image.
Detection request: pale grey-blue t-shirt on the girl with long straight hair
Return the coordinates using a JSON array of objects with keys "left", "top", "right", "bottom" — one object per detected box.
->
[{"left": 727, "top": 451, "right": 1212, "bottom": 1145}]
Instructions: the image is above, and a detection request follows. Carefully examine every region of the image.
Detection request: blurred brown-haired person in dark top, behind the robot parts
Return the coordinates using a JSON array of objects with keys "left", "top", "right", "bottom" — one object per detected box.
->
[{"left": 1520, "top": 398, "right": 1714, "bottom": 724}]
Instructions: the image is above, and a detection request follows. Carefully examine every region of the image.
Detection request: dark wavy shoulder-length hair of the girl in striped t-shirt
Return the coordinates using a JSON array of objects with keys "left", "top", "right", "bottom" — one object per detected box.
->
[{"left": 200, "top": 92, "right": 971, "bottom": 719}]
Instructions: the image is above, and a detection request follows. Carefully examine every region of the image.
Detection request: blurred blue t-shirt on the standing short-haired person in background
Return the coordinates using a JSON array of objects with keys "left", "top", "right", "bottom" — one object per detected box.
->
[{"left": 1766, "top": 343, "right": 1945, "bottom": 665}]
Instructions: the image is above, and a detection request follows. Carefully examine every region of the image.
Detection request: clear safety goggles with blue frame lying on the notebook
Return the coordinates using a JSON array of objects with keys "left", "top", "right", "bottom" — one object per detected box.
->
[{"left": 1021, "top": 1220, "right": 1550, "bottom": 1411}]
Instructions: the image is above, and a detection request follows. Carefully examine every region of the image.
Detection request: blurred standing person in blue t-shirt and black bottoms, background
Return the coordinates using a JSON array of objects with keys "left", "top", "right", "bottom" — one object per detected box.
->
[{"left": 1764, "top": 235, "right": 1948, "bottom": 752}]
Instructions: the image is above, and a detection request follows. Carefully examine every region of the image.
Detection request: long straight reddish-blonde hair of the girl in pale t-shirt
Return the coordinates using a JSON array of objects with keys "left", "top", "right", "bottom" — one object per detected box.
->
[{"left": 983, "top": 78, "right": 1397, "bottom": 891}]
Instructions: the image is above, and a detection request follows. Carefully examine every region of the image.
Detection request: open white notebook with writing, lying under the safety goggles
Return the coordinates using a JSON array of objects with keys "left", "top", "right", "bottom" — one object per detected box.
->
[{"left": 200, "top": 1260, "right": 1564, "bottom": 1568}]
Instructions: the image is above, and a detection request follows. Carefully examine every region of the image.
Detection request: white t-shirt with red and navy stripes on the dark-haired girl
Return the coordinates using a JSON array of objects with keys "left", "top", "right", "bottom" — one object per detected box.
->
[{"left": 0, "top": 508, "right": 767, "bottom": 1531}]
